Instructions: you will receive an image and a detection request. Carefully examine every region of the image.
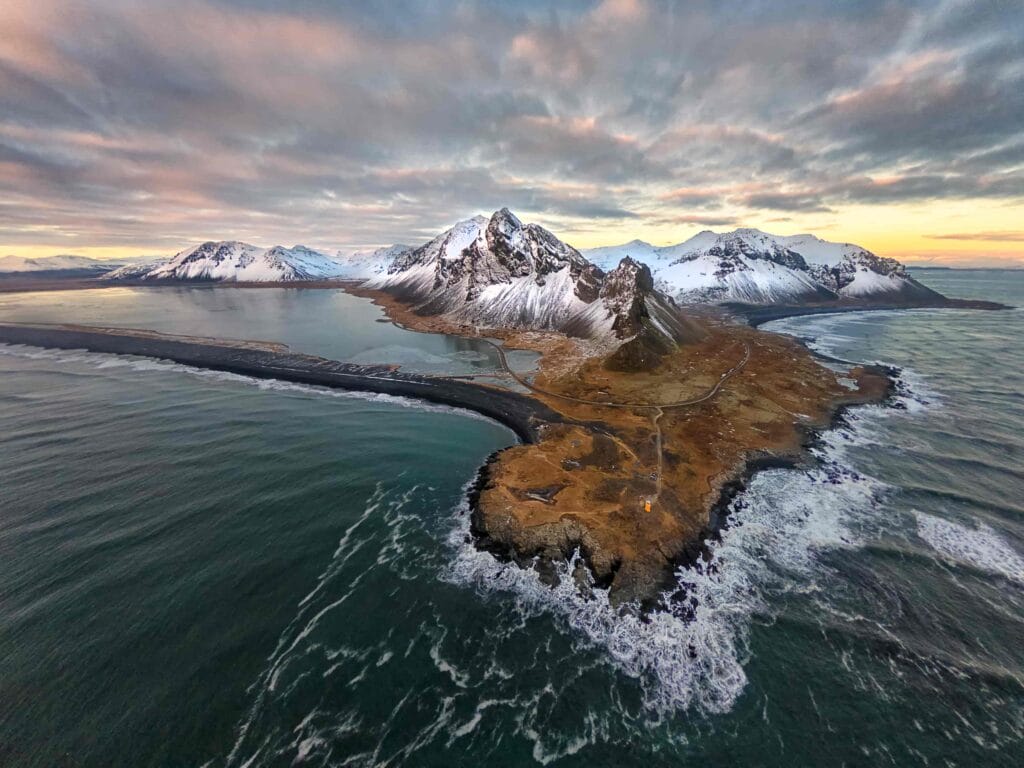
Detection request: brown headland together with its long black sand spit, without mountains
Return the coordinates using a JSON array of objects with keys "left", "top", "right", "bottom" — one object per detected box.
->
[{"left": 0, "top": 309, "right": 893, "bottom": 610}]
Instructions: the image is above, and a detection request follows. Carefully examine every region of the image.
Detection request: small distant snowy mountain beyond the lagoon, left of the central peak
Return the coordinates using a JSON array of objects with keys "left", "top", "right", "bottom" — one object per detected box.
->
[{"left": 103, "top": 241, "right": 343, "bottom": 283}]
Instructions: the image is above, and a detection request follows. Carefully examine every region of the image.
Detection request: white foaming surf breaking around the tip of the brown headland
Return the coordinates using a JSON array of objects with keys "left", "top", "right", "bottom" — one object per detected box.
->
[{"left": 446, "top": 319, "right": 936, "bottom": 714}]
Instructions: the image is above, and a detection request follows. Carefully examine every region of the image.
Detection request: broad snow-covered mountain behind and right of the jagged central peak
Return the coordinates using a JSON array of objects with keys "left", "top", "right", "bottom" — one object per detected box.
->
[{"left": 584, "top": 228, "right": 938, "bottom": 304}]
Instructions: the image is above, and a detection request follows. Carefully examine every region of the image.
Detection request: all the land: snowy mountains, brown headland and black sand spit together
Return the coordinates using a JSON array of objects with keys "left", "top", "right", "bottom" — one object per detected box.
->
[{"left": 0, "top": 209, "right": 998, "bottom": 609}]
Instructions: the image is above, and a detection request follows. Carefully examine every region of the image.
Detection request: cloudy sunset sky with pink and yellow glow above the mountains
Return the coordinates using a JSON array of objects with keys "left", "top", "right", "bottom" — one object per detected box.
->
[{"left": 0, "top": 0, "right": 1024, "bottom": 265}]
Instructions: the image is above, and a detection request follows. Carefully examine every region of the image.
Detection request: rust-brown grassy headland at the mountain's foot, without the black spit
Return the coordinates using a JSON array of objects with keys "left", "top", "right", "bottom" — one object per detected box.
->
[{"left": 351, "top": 288, "right": 893, "bottom": 610}]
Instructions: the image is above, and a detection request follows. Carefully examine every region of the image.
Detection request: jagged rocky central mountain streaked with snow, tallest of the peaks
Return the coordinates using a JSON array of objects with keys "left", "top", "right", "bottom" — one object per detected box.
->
[{"left": 365, "top": 208, "right": 692, "bottom": 339}]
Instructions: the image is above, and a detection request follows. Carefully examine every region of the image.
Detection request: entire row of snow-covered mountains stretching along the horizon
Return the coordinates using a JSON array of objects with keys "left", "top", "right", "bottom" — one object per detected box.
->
[{"left": 94, "top": 208, "right": 966, "bottom": 331}]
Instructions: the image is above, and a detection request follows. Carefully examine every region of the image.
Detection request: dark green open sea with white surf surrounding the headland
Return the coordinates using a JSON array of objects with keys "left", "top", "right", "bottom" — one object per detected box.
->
[{"left": 0, "top": 271, "right": 1024, "bottom": 767}]
